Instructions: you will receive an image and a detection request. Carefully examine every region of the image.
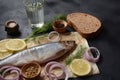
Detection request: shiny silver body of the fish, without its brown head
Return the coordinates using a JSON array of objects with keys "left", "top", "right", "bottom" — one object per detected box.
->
[{"left": 0, "top": 43, "right": 65, "bottom": 65}]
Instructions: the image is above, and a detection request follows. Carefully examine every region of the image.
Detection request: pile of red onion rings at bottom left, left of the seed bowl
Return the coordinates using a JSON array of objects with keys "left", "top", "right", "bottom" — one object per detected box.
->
[{"left": 0, "top": 66, "right": 21, "bottom": 80}]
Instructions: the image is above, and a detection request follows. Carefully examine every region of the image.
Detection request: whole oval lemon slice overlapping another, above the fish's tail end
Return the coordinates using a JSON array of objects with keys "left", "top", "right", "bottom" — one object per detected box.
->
[{"left": 5, "top": 39, "right": 26, "bottom": 51}]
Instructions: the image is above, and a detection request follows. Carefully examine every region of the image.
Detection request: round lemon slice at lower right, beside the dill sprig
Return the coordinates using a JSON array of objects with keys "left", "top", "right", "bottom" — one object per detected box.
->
[{"left": 70, "top": 59, "right": 91, "bottom": 76}]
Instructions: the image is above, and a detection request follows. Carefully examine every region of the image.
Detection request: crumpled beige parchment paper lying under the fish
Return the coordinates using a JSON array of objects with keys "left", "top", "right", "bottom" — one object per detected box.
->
[{"left": 27, "top": 32, "right": 100, "bottom": 77}]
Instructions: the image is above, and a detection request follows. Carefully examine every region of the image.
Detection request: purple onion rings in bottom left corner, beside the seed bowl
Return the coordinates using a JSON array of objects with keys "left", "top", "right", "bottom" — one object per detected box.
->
[{"left": 1, "top": 66, "right": 21, "bottom": 80}]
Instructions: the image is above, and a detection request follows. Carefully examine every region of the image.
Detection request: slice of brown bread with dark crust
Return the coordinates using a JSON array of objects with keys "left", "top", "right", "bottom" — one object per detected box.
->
[{"left": 67, "top": 13, "right": 101, "bottom": 38}]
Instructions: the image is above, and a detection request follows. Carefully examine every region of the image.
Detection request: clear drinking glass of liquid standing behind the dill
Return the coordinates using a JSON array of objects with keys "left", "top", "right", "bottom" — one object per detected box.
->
[{"left": 24, "top": 0, "right": 44, "bottom": 28}]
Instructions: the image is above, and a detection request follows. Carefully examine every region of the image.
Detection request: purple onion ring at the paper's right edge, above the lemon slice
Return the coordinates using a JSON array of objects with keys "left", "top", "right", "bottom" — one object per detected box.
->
[{"left": 84, "top": 47, "right": 100, "bottom": 63}]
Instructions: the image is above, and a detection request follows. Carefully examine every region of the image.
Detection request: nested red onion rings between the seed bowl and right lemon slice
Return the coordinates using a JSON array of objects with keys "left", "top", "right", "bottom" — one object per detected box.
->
[{"left": 44, "top": 61, "right": 69, "bottom": 80}]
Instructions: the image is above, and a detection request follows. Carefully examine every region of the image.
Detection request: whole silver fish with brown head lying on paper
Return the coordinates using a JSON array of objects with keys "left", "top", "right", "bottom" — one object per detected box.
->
[{"left": 0, "top": 41, "right": 75, "bottom": 66}]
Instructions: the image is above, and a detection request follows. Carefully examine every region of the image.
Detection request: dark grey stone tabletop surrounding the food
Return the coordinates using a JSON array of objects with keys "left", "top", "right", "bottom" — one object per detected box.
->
[{"left": 0, "top": 0, "right": 120, "bottom": 80}]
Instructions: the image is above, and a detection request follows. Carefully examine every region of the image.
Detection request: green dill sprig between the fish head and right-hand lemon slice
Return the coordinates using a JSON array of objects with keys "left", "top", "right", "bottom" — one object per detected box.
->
[{"left": 65, "top": 45, "right": 86, "bottom": 65}]
